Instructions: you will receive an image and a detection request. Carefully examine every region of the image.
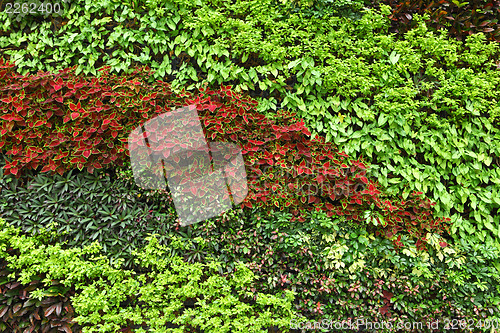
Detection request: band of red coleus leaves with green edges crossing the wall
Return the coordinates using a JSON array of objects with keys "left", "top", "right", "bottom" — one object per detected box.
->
[{"left": 0, "top": 59, "right": 449, "bottom": 248}]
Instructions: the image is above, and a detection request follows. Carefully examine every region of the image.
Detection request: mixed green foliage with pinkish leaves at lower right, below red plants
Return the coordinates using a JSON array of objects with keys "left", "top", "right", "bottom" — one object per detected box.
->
[{"left": 234, "top": 211, "right": 500, "bottom": 331}]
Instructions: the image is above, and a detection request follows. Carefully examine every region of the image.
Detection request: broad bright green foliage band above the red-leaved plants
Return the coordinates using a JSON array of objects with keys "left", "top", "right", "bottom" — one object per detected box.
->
[{"left": 0, "top": 0, "right": 500, "bottom": 249}]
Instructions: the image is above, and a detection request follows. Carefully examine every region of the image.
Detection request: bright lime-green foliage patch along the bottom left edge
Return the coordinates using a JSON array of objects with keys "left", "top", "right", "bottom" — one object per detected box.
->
[{"left": 0, "top": 221, "right": 295, "bottom": 332}]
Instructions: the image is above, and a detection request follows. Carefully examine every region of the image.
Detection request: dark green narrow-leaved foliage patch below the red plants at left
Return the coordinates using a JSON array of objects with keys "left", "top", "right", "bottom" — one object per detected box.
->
[{"left": 0, "top": 150, "right": 176, "bottom": 266}]
